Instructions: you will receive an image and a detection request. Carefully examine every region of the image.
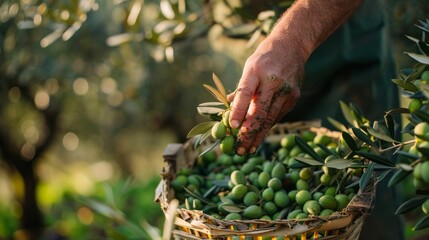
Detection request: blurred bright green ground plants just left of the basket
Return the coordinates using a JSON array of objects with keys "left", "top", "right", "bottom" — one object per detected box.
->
[{"left": 67, "top": 178, "right": 162, "bottom": 239}]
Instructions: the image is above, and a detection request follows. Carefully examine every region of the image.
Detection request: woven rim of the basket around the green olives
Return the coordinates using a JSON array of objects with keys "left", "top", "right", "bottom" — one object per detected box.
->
[{"left": 155, "top": 120, "right": 377, "bottom": 239}]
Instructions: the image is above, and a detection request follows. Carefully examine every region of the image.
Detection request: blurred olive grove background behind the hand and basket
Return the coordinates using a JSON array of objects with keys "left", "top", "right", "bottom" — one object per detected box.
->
[{"left": 0, "top": 0, "right": 429, "bottom": 239}]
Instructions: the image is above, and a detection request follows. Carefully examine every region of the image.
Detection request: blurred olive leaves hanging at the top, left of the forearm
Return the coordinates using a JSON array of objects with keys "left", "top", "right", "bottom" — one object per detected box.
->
[{"left": 107, "top": 0, "right": 293, "bottom": 62}]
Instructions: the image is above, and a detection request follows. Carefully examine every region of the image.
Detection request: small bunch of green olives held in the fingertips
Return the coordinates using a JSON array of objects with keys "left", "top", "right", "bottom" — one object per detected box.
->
[{"left": 211, "top": 110, "right": 239, "bottom": 154}]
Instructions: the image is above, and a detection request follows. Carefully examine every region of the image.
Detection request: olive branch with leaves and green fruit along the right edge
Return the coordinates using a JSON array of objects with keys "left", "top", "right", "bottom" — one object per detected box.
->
[{"left": 388, "top": 20, "right": 429, "bottom": 230}]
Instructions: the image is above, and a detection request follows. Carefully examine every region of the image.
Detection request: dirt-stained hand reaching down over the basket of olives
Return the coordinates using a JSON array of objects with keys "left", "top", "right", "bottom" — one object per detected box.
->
[{"left": 228, "top": 40, "right": 306, "bottom": 155}]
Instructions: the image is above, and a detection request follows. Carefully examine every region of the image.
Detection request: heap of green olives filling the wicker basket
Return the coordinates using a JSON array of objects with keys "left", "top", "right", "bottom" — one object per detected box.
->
[{"left": 171, "top": 129, "right": 359, "bottom": 220}]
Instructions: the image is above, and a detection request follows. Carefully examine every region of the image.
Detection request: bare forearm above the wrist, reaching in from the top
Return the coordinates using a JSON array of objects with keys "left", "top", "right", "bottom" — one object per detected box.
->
[{"left": 264, "top": 0, "right": 363, "bottom": 60}]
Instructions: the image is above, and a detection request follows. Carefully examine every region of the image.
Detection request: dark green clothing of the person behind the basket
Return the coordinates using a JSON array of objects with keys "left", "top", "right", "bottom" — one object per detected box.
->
[{"left": 284, "top": 0, "right": 404, "bottom": 240}]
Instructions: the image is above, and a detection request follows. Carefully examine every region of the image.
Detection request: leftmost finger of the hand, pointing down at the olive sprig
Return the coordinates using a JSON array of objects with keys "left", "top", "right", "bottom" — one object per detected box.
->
[{"left": 229, "top": 74, "right": 259, "bottom": 128}]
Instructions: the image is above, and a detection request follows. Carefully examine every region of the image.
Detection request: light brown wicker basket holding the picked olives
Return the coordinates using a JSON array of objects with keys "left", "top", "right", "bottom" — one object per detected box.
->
[{"left": 155, "top": 121, "right": 375, "bottom": 240}]
